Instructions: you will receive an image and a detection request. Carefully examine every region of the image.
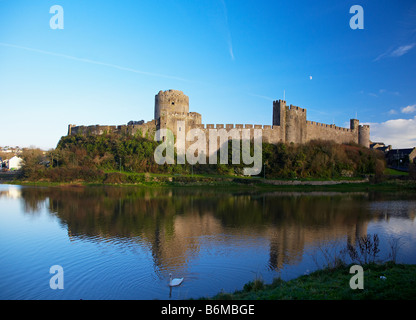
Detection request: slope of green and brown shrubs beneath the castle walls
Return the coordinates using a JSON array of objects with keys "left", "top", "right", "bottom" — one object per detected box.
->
[{"left": 17, "top": 134, "right": 385, "bottom": 182}]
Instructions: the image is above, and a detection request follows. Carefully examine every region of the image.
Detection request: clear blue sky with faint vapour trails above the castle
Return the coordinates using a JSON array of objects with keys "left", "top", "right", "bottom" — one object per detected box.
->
[{"left": 0, "top": 0, "right": 416, "bottom": 149}]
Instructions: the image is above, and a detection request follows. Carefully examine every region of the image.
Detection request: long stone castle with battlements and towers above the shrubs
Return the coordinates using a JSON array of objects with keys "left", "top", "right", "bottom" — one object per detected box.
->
[{"left": 68, "top": 90, "right": 370, "bottom": 148}]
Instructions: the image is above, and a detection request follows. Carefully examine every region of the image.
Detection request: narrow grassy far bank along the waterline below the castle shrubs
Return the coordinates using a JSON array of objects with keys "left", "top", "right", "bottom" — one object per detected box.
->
[{"left": 4, "top": 172, "right": 416, "bottom": 192}]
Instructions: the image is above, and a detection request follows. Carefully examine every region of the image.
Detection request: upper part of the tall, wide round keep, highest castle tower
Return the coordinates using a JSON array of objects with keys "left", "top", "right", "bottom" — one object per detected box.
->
[{"left": 155, "top": 90, "right": 189, "bottom": 120}]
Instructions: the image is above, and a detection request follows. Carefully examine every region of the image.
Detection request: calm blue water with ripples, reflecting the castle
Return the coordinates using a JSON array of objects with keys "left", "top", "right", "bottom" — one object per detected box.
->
[{"left": 0, "top": 185, "right": 416, "bottom": 299}]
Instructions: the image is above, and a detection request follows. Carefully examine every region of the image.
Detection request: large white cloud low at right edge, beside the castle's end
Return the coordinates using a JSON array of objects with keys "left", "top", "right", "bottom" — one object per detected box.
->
[{"left": 368, "top": 116, "right": 416, "bottom": 148}]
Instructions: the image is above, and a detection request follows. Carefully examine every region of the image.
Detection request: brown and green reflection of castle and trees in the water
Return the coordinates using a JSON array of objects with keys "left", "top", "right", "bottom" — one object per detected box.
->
[{"left": 8, "top": 187, "right": 416, "bottom": 270}]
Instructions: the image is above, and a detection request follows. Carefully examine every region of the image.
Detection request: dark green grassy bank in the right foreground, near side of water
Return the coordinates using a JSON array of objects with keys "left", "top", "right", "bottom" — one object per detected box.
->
[{"left": 204, "top": 262, "right": 416, "bottom": 300}]
